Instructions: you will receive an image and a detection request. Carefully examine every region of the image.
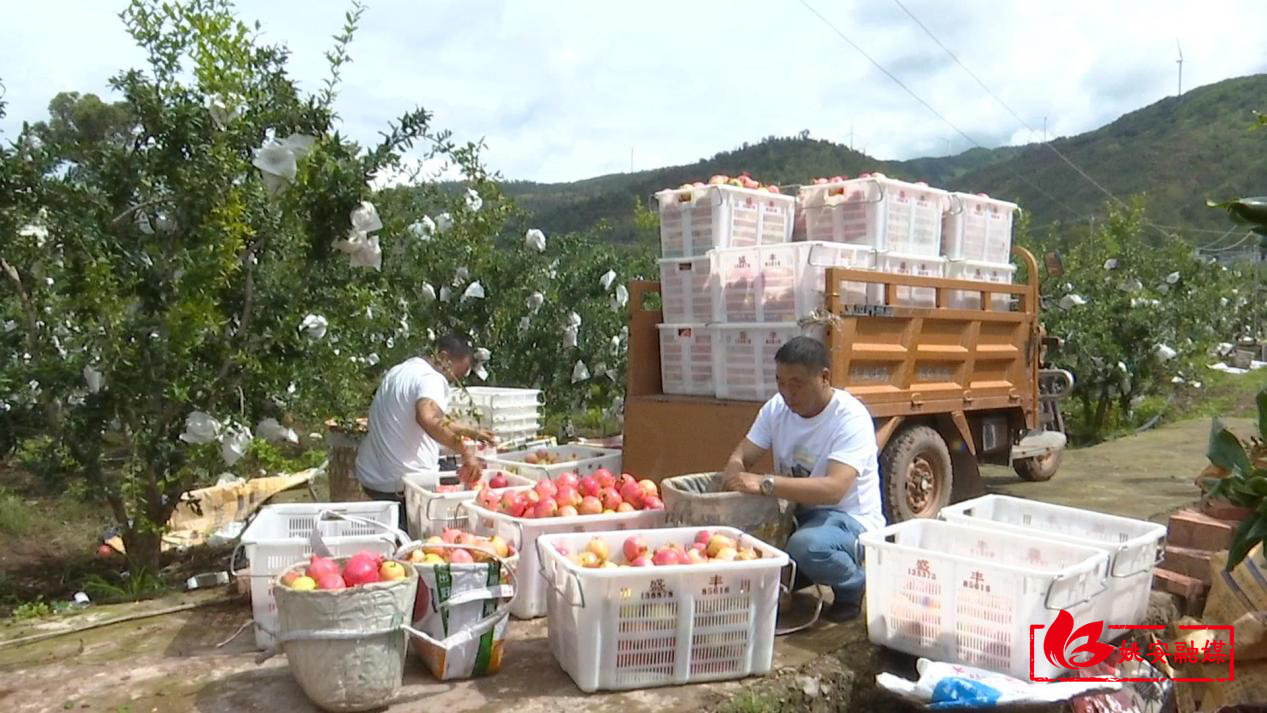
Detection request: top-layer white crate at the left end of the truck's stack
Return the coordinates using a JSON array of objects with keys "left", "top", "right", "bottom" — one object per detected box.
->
[{"left": 655, "top": 186, "right": 796, "bottom": 258}]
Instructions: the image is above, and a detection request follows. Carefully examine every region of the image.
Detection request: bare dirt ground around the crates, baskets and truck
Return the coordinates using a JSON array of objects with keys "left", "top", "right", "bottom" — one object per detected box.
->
[{"left": 0, "top": 419, "right": 1248, "bottom": 713}]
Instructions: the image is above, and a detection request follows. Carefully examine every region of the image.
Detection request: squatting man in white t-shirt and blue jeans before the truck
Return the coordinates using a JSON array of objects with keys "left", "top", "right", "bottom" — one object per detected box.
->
[{"left": 723, "top": 337, "right": 884, "bottom": 622}]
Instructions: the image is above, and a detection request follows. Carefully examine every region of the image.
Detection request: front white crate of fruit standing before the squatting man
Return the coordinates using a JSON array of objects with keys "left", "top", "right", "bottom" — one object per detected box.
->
[{"left": 537, "top": 527, "right": 788, "bottom": 693}]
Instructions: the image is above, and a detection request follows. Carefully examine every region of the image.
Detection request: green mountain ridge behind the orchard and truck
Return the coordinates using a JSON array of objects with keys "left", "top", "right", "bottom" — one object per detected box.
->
[{"left": 503, "top": 75, "right": 1267, "bottom": 243}]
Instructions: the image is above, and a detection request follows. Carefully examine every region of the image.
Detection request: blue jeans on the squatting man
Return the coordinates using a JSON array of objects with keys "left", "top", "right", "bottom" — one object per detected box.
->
[{"left": 788, "top": 508, "right": 867, "bottom": 604}]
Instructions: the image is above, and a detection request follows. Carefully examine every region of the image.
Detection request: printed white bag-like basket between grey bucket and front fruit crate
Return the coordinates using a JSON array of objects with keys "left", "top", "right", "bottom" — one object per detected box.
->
[{"left": 398, "top": 543, "right": 518, "bottom": 681}]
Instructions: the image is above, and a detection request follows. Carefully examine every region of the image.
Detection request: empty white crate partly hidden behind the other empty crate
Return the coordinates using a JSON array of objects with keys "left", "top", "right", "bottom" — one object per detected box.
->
[{"left": 941, "top": 495, "right": 1166, "bottom": 630}]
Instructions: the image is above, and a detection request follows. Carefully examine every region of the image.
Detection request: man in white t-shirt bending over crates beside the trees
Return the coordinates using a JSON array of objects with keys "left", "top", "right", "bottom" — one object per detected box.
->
[{"left": 356, "top": 334, "right": 493, "bottom": 519}]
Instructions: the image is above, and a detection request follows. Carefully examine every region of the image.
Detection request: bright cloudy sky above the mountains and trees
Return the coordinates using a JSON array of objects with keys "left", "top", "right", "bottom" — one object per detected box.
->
[{"left": 0, "top": 0, "right": 1267, "bottom": 181}]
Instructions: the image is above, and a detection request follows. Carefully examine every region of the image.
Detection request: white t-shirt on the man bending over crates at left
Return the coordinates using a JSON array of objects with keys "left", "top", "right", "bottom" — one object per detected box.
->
[{"left": 356, "top": 357, "right": 449, "bottom": 493}]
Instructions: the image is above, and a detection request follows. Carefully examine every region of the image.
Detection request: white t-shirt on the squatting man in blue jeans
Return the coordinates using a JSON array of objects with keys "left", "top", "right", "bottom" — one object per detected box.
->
[{"left": 748, "top": 389, "right": 884, "bottom": 529}]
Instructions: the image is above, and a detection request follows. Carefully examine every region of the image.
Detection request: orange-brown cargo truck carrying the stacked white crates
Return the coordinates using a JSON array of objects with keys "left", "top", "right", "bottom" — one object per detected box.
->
[{"left": 625, "top": 248, "right": 1064, "bottom": 521}]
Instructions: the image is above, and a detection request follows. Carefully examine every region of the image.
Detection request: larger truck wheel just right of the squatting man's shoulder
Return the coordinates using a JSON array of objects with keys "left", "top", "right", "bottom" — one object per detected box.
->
[{"left": 879, "top": 426, "right": 953, "bottom": 523}]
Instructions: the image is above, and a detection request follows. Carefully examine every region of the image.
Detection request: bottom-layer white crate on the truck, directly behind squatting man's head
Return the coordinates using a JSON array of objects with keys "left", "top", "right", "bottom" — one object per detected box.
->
[{"left": 710, "top": 322, "right": 824, "bottom": 401}]
